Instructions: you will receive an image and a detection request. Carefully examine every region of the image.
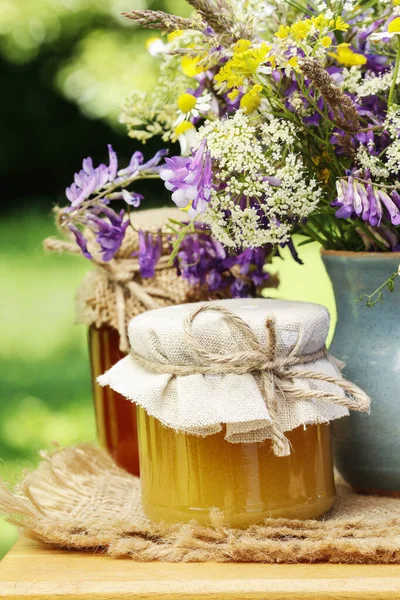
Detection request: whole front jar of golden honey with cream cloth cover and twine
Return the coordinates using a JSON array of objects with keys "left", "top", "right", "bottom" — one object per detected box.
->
[{"left": 99, "top": 299, "right": 367, "bottom": 528}]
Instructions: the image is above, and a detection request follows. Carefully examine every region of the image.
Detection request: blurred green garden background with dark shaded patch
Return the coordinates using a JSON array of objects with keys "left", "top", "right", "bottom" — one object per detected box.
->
[{"left": 0, "top": 0, "right": 334, "bottom": 557}]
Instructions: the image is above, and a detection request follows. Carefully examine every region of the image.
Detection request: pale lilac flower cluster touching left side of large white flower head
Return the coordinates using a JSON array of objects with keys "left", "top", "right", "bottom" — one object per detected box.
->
[{"left": 160, "top": 139, "right": 212, "bottom": 217}]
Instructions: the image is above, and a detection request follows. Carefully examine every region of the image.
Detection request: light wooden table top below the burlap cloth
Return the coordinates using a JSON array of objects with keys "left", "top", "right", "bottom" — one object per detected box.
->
[{"left": 0, "top": 538, "right": 400, "bottom": 600}]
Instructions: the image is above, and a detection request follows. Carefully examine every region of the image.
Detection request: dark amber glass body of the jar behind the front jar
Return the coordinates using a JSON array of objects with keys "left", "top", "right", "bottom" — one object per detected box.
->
[{"left": 88, "top": 325, "right": 139, "bottom": 476}]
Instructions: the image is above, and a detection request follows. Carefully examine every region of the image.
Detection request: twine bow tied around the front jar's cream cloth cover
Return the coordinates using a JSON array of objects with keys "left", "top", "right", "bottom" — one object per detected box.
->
[{"left": 131, "top": 303, "right": 370, "bottom": 456}]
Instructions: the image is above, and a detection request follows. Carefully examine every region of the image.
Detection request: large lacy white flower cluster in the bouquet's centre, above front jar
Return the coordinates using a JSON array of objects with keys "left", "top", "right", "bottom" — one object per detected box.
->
[{"left": 197, "top": 110, "right": 321, "bottom": 248}]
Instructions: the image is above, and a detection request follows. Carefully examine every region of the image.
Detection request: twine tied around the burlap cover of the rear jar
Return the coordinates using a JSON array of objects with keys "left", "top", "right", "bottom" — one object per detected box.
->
[{"left": 44, "top": 238, "right": 173, "bottom": 354}]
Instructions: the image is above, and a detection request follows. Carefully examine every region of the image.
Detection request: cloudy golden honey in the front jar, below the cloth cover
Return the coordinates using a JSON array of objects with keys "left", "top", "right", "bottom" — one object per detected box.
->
[{"left": 138, "top": 408, "right": 335, "bottom": 528}]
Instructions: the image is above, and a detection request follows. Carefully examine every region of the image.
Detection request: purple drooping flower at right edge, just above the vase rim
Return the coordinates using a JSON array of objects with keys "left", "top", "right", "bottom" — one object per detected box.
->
[{"left": 332, "top": 171, "right": 400, "bottom": 227}]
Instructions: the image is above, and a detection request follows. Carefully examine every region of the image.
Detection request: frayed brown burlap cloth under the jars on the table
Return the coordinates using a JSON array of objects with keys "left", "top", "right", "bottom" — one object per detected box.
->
[{"left": 0, "top": 445, "right": 400, "bottom": 564}]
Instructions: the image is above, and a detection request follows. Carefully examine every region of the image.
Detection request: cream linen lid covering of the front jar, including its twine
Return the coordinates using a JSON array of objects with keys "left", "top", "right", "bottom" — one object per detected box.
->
[{"left": 98, "top": 299, "right": 368, "bottom": 454}]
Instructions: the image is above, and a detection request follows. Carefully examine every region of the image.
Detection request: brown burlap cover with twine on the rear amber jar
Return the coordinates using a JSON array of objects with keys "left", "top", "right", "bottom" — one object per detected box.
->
[{"left": 44, "top": 208, "right": 229, "bottom": 352}]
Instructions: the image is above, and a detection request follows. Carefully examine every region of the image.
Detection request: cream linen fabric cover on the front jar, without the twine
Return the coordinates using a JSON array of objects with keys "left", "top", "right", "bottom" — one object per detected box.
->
[{"left": 98, "top": 299, "right": 369, "bottom": 455}]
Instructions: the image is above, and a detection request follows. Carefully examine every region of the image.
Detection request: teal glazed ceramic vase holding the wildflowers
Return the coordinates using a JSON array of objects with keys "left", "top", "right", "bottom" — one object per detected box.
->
[{"left": 322, "top": 251, "right": 400, "bottom": 495}]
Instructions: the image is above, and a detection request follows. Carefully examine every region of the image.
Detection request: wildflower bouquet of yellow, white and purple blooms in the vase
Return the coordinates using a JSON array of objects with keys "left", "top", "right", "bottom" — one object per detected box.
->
[{"left": 60, "top": 0, "right": 400, "bottom": 298}]
